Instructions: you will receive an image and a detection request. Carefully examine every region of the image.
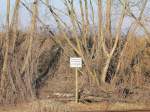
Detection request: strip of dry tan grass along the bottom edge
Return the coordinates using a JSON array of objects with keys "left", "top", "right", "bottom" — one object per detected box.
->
[{"left": 0, "top": 100, "right": 149, "bottom": 112}]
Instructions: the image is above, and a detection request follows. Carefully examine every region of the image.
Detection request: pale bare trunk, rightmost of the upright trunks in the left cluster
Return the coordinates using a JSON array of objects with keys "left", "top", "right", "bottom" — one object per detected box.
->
[{"left": 21, "top": 0, "right": 38, "bottom": 99}]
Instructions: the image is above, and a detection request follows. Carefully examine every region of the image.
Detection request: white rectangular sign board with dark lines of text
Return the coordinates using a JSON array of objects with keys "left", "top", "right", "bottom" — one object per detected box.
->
[{"left": 70, "top": 57, "right": 82, "bottom": 68}]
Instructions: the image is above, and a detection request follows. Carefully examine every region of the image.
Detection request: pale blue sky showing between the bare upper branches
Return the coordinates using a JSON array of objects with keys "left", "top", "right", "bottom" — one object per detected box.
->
[{"left": 0, "top": 0, "right": 150, "bottom": 34}]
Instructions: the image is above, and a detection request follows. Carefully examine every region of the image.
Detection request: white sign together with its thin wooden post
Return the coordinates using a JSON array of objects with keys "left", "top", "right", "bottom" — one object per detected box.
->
[{"left": 70, "top": 57, "right": 82, "bottom": 103}]
